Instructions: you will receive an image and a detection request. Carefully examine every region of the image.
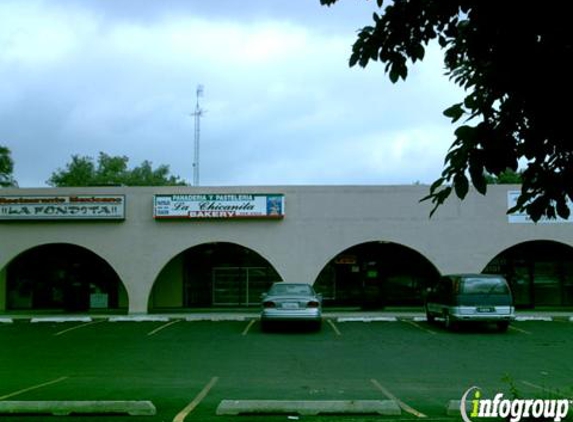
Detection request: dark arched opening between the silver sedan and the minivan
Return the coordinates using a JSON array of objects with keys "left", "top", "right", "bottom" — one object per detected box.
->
[{"left": 315, "top": 242, "right": 439, "bottom": 308}]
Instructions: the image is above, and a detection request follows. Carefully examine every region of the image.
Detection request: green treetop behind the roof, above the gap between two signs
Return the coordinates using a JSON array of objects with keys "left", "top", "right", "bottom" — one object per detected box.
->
[{"left": 47, "top": 152, "right": 185, "bottom": 187}]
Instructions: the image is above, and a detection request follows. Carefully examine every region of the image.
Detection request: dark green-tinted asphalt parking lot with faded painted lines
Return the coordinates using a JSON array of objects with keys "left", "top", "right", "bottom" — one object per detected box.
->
[{"left": 0, "top": 317, "right": 573, "bottom": 422}]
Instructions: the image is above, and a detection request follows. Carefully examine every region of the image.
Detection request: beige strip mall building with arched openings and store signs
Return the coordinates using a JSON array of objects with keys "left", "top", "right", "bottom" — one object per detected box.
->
[{"left": 0, "top": 185, "right": 573, "bottom": 314}]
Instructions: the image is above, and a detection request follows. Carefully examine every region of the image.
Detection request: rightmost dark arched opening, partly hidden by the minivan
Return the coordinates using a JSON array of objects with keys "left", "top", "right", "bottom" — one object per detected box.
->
[{"left": 483, "top": 240, "right": 573, "bottom": 308}]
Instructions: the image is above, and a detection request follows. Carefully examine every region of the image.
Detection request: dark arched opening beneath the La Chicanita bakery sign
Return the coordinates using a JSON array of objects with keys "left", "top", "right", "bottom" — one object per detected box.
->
[{"left": 149, "top": 242, "right": 282, "bottom": 311}]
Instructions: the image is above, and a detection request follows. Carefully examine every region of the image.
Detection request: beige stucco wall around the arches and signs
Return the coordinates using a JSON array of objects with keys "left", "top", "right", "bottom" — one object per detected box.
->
[{"left": 0, "top": 185, "right": 573, "bottom": 313}]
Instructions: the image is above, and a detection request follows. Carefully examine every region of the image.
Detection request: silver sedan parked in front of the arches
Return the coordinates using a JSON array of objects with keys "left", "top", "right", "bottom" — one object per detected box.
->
[{"left": 261, "top": 282, "right": 322, "bottom": 330}]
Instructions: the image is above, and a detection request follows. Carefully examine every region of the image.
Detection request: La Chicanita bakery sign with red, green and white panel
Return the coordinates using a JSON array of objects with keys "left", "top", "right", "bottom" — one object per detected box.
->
[{"left": 153, "top": 193, "right": 285, "bottom": 220}]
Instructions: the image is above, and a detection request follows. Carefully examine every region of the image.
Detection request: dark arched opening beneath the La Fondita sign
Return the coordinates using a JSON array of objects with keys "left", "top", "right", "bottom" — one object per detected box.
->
[{"left": 6, "top": 243, "right": 128, "bottom": 312}]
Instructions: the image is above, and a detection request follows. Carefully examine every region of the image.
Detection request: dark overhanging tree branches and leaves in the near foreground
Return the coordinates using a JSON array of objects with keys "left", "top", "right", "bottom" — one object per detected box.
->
[{"left": 321, "top": 0, "right": 573, "bottom": 221}]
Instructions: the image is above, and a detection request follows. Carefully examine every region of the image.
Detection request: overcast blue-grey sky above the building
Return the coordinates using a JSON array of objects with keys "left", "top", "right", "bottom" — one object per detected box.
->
[{"left": 0, "top": 0, "right": 462, "bottom": 187}]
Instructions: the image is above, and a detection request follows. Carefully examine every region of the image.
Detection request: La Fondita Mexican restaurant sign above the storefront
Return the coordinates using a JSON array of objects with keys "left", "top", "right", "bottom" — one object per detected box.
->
[{"left": 0, "top": 195, "right": 125, "bottom": 220}]
